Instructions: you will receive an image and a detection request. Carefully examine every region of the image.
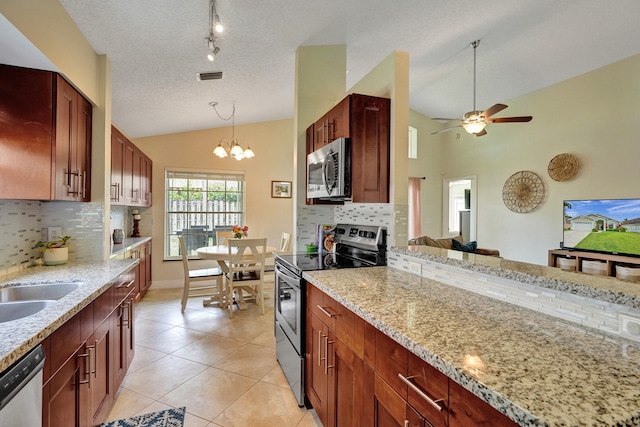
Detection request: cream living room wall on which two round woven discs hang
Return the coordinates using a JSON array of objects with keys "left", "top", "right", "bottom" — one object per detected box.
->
[{"left": 420, "top": 51, "right": 640, "bottom": 265}]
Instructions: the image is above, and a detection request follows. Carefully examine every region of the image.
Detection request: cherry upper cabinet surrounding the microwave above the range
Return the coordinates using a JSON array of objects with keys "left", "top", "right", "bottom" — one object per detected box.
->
[{"left": 307, "top": 94, "right": 391, "bottom": 204}]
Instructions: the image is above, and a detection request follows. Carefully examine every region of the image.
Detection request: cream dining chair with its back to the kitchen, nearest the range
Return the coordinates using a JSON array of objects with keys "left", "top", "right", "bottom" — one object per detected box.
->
[{"left": 225, "top": 238, "right": 267, "bottom": 319}]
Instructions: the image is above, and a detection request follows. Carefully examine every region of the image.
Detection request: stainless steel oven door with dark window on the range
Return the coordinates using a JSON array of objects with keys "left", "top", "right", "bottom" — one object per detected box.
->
[{"left": 275, "top": 262, "right": 305, "bottom": 355}]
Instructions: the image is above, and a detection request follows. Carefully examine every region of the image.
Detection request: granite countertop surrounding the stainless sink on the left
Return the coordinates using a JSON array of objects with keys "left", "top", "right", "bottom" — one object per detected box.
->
[{"left": 0, "top": 259, "right": 139, "bottom": 372}]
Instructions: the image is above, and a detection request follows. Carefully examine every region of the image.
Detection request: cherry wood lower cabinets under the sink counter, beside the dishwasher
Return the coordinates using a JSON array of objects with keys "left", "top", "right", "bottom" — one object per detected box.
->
[{"left": 42, "top": 270, "right": 134, "bottom": 427}]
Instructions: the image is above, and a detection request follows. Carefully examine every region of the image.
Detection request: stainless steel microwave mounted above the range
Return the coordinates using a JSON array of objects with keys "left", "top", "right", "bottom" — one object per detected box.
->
[{"left": 307, "top": 138, "right": 351, "bottom": 200}]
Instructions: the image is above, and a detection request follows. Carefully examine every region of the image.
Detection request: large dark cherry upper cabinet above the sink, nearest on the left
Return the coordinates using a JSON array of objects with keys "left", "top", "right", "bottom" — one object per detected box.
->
[{"left": 0, "top": 65, "right": 92, "bottom": 201}]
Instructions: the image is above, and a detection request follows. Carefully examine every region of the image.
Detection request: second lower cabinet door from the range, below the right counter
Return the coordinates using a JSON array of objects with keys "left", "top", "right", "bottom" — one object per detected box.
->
[{"left": 327, "top": 333, "right": 364, "bottom": 427}]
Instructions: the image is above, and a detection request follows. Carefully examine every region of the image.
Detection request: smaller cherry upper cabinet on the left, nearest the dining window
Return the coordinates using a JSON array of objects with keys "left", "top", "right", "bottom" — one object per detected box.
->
[{"left": 111, "top": 126, "right": 153, "bottom": 206}]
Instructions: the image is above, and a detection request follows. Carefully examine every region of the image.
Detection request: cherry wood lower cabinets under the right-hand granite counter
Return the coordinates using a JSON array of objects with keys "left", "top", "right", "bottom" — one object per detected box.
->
[{"left": 305, "top": 284, "right": 517, "bottom": 427}]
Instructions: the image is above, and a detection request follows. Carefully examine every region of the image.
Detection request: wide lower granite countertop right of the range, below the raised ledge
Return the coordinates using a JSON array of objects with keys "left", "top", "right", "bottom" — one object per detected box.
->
[{"left": 304, "top": 268, "right": 640, "bottom": 426}]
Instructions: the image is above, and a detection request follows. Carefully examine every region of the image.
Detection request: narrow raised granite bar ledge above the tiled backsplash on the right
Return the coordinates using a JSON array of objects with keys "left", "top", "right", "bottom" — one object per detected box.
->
[{"left": 389, "top": 246, "right": 640, "bottom": 309}]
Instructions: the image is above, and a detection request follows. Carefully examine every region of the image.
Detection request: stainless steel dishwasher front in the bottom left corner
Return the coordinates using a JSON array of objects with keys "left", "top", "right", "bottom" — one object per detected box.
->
[{"left": 0, "top": 344, "right": 45, "bottom": 427}]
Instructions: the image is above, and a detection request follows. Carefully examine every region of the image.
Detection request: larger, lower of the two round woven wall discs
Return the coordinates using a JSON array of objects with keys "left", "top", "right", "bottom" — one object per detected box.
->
[{"left": 502, "top": 171, "right": 544, "bottom": 213}]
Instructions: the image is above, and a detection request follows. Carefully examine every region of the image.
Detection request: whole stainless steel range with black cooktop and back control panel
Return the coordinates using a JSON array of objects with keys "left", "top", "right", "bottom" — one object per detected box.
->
[{"left": 274, "top": 224, "right": 387, "bottom": 406}]
